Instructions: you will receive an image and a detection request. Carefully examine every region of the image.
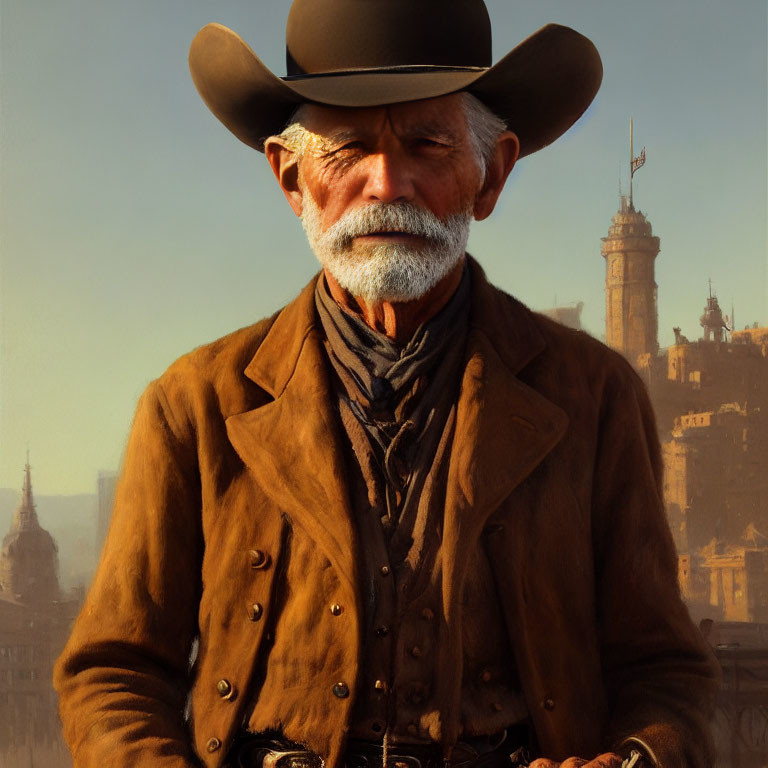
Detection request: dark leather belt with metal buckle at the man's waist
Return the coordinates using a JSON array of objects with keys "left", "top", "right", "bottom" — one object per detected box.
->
[{"left": 223, "top": 727, "right": 528, "bottom": 768}]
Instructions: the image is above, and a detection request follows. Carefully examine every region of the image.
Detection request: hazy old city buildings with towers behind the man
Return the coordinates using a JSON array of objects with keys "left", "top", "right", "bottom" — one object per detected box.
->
[{"left": 0, "top": 192, "right": 768, "bottom": 768}]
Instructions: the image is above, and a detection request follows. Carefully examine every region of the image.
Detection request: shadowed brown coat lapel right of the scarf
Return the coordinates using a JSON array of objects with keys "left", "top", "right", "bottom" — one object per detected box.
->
[{"left": 444, "top": 260, "right": 568, "bottom": 572}]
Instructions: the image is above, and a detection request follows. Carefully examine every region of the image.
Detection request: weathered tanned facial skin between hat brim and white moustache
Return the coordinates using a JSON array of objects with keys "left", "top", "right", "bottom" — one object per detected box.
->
[{"left": 301, "top": 94, "right": 482, "bottom": 228}]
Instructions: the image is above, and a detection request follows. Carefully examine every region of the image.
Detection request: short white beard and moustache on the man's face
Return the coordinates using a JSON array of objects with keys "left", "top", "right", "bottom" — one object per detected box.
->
[{"left": 301, "top": 190, "right": 472, "bottom": 302}]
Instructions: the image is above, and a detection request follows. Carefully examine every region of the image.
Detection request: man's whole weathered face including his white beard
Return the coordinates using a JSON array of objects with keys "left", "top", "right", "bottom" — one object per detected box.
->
[{"left": 267, "top": 94, "right": 514, "bottom": 301}]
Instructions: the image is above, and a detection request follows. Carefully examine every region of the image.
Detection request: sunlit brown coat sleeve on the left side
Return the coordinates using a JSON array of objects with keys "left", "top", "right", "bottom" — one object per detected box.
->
[{"left": 54, "top": 382, "right": 202, "bottom": 768}]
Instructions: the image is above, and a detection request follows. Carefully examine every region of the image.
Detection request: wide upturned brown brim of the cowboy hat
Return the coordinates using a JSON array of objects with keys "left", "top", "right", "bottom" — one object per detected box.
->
[{"left": 189, "top": 24, "right": 603, "bottom": 157}]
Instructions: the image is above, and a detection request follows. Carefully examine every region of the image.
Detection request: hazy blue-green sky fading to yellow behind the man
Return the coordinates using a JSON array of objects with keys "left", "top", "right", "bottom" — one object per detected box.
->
[{"left": 0, "top": 0, "right": 768, "bottom": 494}]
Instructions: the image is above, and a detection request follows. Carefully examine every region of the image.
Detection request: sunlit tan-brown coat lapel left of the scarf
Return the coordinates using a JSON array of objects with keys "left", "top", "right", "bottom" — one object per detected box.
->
[{"left": 226, "top": 280, "right": 356, "bottom": 585}]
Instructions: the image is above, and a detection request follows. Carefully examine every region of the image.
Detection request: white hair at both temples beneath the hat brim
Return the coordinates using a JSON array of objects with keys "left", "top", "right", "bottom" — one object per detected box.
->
[{"left": 276, "top": 91, "right": 507, "bottom": 177}]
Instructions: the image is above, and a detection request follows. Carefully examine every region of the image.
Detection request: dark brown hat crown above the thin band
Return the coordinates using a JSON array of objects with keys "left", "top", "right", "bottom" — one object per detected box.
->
[{"left": 286, "top": 0, "right": 492, "bottom": 76}]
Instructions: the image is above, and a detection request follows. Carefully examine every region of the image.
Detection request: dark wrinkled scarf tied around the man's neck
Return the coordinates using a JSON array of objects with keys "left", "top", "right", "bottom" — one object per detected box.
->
[{"left": 315, "top": 267, "right": 470, "bottom": 529}]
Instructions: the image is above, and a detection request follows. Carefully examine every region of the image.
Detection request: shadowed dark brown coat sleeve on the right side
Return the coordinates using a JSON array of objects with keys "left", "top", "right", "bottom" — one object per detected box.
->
[{"left": 593, "top": 366, "right": 719, "bottom": 768}]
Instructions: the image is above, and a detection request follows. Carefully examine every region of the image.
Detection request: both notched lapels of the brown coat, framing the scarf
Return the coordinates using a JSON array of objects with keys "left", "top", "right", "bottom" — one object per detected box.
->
[{"left": 226, "top": 258, "right": 567, "bottom": 584}]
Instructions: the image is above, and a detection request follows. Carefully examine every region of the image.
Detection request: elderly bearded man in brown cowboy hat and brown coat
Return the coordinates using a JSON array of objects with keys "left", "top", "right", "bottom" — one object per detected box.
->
[{"left": 56, "top": 0, "right": 715, "bottom": 768}]
